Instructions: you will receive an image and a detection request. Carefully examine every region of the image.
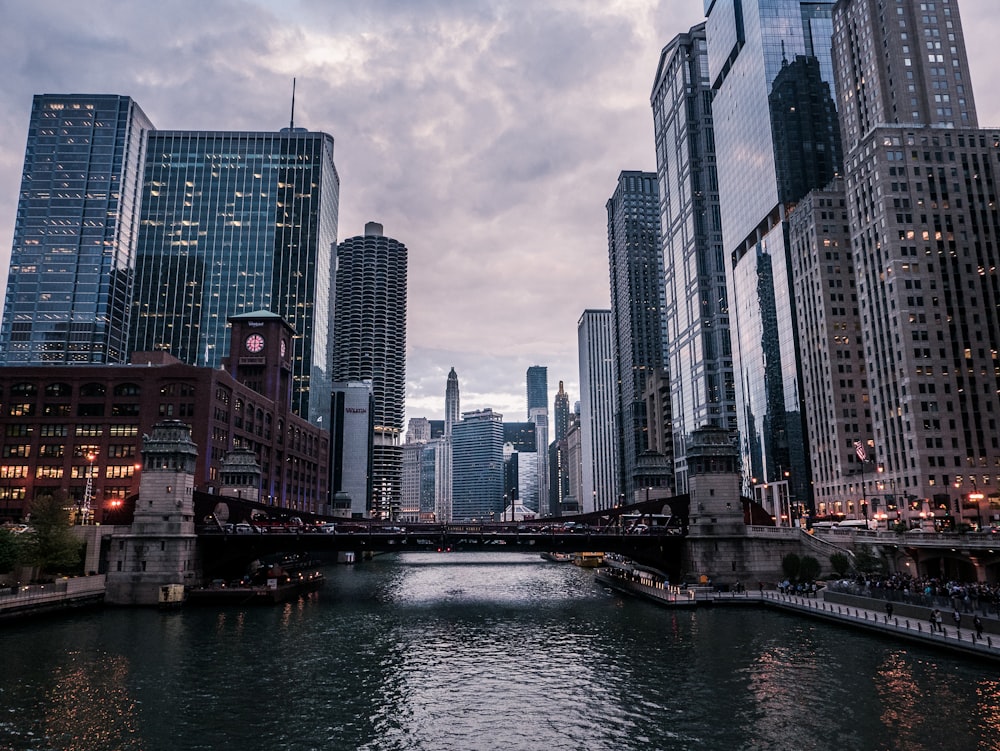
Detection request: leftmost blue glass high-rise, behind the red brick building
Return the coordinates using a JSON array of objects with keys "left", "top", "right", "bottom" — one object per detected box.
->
[{"left": 0, "top": 94, "right": 153, "bottom": 366}]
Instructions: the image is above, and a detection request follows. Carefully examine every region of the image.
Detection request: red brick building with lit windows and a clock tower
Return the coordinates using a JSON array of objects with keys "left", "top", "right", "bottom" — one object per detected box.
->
[{"left": 0, "top": 311, "right": 329, "bottom": 521}]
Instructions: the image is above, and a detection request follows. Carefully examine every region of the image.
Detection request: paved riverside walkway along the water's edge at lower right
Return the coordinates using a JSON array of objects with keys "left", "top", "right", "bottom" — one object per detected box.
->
[{"left": 756, "top": 590, "right": 1000, "bottom": 661}]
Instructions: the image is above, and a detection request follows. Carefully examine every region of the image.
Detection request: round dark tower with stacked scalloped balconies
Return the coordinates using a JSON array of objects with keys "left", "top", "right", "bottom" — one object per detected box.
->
[{"left": 333, "top": 222, "right": 407, "bottom": 518}]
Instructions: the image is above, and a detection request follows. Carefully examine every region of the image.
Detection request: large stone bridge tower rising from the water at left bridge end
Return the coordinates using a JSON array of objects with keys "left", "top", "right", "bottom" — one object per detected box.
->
[{"left": 105, "top": 420, "right": 198, "bottom": 605}]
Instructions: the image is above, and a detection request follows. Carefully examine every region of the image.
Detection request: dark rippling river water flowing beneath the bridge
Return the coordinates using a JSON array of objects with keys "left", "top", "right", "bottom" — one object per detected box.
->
[{"left": 0, "top": 553, "right": 1000, "bottom": 751}]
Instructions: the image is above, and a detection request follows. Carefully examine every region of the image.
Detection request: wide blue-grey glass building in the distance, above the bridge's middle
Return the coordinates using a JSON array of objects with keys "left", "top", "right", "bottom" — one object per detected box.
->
[{"left": 451, "top": 409, "right": 504, "bottom": 521}]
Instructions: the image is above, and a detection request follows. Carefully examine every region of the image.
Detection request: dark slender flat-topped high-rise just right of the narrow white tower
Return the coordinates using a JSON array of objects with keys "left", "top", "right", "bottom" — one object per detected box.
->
[{"left": 607, "top": 172, "right": 666, "bottom": 498}]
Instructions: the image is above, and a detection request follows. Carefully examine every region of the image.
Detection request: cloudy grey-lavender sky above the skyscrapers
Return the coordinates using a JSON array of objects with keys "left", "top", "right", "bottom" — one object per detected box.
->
[{"left": 0, "top": 0, "right": 1000, "bottom": 432}]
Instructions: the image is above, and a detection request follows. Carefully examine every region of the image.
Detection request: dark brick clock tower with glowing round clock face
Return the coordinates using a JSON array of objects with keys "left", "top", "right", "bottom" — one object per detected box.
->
[{"left": 222, "top": 310, "right": 294, "bottom": 417}]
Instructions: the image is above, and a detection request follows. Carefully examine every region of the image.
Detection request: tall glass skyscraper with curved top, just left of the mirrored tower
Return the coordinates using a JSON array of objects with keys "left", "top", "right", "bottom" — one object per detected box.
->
[{"left": 647, "top": 24, "right": 737, "bottom": 493}]
